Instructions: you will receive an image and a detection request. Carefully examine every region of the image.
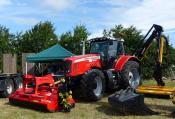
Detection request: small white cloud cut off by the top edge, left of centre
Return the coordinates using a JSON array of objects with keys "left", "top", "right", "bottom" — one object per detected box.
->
[{"left": 40, "top": 0, "right": 72, "bottom": 11}]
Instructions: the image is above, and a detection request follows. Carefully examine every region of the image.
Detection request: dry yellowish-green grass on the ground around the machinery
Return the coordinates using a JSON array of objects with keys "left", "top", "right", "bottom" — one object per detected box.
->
[{"left": 0, "top": 81, "right": 175, "bottom": 119}]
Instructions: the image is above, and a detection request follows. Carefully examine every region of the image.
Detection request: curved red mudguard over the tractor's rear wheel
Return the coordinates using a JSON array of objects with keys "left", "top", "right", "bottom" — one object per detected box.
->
[{"left": 114, "top": 55, "right": 140, "bottom": 72}]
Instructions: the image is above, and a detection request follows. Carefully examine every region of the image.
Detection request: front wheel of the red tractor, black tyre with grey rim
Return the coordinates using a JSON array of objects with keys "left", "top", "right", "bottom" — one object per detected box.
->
[{"left": 80, "top": 69, "right": 105, "bottom": 101}]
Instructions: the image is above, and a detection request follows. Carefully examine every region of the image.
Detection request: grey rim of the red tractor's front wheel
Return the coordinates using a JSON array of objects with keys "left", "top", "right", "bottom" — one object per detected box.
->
[{"left": 93, "top": 76, "right": 102, "bottom": 96}]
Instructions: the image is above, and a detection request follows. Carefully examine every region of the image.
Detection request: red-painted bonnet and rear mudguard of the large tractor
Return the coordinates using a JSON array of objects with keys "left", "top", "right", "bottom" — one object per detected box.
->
[{"left": 65, "top": 54, "right": 138, "bottom": 77}]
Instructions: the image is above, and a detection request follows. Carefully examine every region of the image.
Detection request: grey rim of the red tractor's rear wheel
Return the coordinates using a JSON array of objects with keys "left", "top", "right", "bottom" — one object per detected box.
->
[{"left": 129, "top": 69, "right": 140, "bottom": 89}]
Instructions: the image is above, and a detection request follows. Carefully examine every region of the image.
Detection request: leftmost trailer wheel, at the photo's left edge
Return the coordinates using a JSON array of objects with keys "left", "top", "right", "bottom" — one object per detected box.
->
[{"left": 1, "top": 78, "right": 14, "bottom": 97}]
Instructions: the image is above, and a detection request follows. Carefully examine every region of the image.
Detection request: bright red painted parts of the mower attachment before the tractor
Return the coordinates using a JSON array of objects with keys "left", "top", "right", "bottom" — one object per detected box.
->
[{"left": 9, "top": 74, "right": 75, "bottom": 111}]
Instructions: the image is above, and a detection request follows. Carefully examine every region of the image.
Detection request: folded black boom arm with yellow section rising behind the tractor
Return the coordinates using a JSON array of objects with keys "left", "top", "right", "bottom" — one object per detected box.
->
[{"left": 135, "top": 24, "right": 168, "bottom": 86}]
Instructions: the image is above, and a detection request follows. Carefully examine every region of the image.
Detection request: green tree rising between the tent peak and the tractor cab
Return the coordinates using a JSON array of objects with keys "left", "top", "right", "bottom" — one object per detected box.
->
[{"left": 60, "top": 25, "right": 90, "bottom": 55}]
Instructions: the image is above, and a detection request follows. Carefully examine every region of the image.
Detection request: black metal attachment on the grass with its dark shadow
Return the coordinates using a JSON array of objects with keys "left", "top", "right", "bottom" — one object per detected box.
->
[{"left": 108, "top": 89, "right": 156, "bottom": 115}]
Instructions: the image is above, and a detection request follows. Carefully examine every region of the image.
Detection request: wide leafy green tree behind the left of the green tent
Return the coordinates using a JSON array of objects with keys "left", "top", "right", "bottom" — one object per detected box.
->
[{"left": 17, "top": 21, "right": 58, "bottom": 53}]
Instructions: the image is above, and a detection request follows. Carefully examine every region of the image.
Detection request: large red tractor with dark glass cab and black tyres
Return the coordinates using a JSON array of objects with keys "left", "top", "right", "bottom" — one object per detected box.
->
[{"left": 65, "top": 37, "right": 141, "bottom": 101}]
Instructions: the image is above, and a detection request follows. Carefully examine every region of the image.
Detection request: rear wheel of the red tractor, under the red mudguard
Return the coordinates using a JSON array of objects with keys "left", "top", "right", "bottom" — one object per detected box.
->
[{"left": 121, "top": 61, "right": 141, "bottom": 89}]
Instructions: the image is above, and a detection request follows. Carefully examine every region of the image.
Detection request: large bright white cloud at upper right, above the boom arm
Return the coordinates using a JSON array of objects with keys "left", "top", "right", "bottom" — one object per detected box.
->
[{"left": 106, "top": 0, "right": 175, "bottom": 29}]
